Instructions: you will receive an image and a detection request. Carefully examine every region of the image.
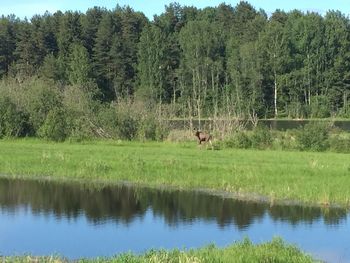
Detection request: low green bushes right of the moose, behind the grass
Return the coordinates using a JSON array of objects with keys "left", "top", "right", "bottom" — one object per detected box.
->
[{"left": 221, "top": 124, "right": 350, "bottom": 153}]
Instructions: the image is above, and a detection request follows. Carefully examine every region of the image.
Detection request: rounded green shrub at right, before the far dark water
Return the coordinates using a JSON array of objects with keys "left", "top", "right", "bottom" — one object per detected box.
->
[{"left": 296, "top": 122, "right": 330, "bottom": 151}]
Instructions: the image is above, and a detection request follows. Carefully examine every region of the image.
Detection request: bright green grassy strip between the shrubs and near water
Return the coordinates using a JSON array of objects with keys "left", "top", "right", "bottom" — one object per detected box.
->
[{"left": 0, "top": 139, "right": 350, "bottom": 207}]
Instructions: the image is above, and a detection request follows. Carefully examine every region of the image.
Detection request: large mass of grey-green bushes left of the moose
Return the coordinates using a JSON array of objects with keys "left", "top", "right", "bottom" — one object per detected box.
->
[{"left": 0, "top": 77, "right": 169, "bottom": 141}]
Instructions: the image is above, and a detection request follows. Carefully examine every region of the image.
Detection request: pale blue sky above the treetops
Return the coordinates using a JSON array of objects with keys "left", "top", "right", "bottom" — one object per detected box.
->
[{"left": 0, "top": 0, "right": 350, "bottom": 18}]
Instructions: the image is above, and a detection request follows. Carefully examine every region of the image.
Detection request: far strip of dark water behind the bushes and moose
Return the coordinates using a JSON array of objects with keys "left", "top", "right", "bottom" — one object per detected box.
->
[{"left": 169, "top": 120, "right": 350, "bottom": 132}]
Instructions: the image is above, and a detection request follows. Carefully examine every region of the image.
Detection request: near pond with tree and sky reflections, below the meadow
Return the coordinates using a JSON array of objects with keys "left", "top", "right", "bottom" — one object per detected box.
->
[{"left": 0, "top": 178, "right": 350, "bottom": 262}]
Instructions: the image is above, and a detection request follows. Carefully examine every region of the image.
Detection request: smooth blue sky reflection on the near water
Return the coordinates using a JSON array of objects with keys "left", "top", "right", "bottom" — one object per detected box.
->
[{"left": 0, "top": 208, "right": 350, "bottom": 262}]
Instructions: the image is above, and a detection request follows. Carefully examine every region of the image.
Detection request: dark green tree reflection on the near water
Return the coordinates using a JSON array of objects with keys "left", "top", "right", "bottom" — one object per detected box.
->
[{"left": 0, "top": 178, "right": 347, "bottom": 229}]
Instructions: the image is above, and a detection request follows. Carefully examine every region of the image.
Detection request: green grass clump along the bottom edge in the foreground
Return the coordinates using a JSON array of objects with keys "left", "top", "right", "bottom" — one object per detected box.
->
[{"left": 0, "top": 238, "right": 315, "bottom": 263}]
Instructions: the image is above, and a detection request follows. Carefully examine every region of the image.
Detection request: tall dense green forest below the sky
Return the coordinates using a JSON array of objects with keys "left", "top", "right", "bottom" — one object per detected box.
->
[{"left": 0, "top": 1, "right": 350, "bottom": 125}]
